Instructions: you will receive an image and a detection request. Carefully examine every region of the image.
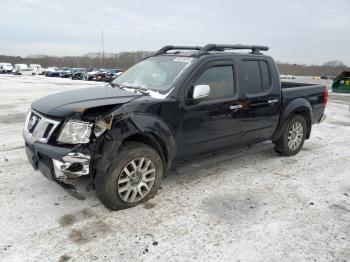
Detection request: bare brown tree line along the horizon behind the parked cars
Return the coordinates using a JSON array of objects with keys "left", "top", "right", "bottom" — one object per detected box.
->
[{"left": 0, "top": 51, "right": 350, "bottom": 76}]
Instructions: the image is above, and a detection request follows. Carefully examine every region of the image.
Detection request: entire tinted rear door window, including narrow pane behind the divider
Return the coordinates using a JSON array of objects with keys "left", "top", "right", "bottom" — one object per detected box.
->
[{"left": 243, "top": 60, "right": 271, "bottom": 95}]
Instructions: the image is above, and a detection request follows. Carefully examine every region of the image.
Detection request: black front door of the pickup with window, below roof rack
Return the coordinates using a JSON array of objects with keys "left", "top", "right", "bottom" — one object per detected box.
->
[{"left": 180, "top": 61, "right": 243, "bottom": 156}]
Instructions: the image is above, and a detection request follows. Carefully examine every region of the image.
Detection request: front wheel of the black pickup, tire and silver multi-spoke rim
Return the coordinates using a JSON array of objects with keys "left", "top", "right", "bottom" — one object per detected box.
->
[{"left": 95, "top": 142, "right": 164, "bottom": 210}]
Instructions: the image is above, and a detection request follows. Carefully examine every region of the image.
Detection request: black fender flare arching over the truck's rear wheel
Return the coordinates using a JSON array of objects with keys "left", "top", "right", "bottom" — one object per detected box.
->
[{"left": 271, "top": 98, "right": 313, "bottom": 141}]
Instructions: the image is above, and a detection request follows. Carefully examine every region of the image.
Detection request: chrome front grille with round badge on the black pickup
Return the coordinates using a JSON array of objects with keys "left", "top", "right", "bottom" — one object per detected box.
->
[{"left": 23, "top": 110, "right": 60, "bottom": 143}]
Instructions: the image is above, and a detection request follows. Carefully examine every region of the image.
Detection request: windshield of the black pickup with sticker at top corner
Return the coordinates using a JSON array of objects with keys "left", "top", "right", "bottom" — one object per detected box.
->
[{"left": 112, "top": 56, "right": 194, "bottom": 92}]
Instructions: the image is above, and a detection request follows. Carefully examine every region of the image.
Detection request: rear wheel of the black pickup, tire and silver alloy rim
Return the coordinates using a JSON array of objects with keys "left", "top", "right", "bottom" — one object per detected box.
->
[{"left": 274, "top": 115, "right": 306, "bottom": 156}]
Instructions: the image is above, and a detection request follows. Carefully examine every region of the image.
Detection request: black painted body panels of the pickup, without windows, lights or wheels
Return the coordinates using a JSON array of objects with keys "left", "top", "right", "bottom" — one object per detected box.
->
[{"left": 26, "top": 52, "right": 326, "bottom": 178}]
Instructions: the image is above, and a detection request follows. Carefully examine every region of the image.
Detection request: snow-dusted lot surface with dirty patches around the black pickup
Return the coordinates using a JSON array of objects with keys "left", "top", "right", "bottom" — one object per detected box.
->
[{"left": 0, "top": 75, "right": 350, "bottom": 261}]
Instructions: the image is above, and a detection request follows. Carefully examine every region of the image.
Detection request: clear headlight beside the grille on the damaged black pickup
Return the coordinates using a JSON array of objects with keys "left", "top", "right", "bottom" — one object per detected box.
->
[{"left": 57, "top": 120, "right": 93, "bottom": 144}]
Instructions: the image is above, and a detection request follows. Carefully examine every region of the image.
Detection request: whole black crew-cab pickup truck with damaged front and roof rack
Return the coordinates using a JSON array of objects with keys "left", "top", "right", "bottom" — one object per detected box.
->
[{"left": 24, "top": 44, "right": 328, "bottom": 210}]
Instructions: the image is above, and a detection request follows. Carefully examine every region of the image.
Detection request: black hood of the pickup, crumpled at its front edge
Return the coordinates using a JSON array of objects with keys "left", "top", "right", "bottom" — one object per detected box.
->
[{"left": 32, "top": 86, "right": 142, "bottom": 118}]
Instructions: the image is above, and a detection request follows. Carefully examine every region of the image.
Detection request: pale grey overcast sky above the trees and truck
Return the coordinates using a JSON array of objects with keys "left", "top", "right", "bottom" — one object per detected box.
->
[{"left": 0, "top": 0, "right": 350, "bottom": 65}]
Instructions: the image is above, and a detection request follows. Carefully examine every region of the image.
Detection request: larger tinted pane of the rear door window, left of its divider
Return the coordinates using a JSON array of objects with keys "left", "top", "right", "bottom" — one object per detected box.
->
[{"left": 243, "top": 60, "right": 262, "bottom": 95}]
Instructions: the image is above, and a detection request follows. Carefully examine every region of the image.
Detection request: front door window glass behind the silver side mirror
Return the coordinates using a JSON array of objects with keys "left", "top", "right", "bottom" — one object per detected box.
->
[{"left": 194, "top": 66, "right": 235, "bottom": 100}]
